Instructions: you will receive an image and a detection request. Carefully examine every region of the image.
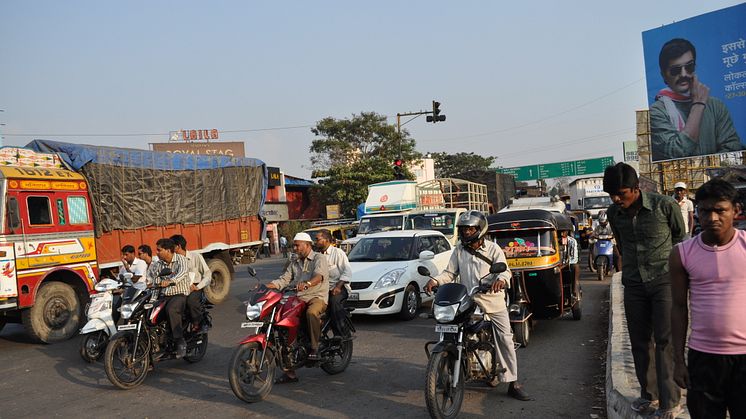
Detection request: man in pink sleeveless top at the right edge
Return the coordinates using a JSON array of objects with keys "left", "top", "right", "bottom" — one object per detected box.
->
[{"left": 669, "top": 179, "right": 746, "bottom": 419}]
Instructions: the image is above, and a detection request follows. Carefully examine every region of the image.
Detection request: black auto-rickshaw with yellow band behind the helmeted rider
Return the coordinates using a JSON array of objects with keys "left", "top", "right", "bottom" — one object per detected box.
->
[{"left": 487, "top": 209, "right": 582, "bottom": 346}]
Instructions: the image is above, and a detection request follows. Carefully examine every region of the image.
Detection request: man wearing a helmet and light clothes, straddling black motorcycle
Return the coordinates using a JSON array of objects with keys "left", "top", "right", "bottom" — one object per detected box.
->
[{"left": 425, "top": 210, "right": 531, "bottom": 401}]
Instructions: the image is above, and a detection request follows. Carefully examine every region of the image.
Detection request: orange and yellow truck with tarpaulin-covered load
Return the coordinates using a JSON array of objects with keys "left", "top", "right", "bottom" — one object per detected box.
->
[{"left": 0, "top": 140, "right": 267, "bottom": 343}]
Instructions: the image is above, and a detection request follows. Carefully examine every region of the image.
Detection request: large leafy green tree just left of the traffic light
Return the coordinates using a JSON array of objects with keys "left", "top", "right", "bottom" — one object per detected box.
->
[{"left": 310, "top": 112, "right": 422, "bottom": 215}]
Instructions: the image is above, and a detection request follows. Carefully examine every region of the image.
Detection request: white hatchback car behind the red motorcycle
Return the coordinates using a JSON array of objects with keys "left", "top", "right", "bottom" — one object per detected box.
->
[{"left": 347, "top": 230, "right": 453, "bottom": 320}]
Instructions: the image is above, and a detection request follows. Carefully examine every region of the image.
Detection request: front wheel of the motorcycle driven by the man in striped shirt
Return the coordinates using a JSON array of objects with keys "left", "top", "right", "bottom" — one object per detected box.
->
[{"left": 104, "top": 333, "right": 150, "bottom": 390}]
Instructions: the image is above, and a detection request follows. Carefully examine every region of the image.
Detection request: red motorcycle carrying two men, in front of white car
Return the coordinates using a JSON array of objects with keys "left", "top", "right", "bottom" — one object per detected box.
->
[{"left": 228, "top": 267, "right": 355, "bottom": 403}]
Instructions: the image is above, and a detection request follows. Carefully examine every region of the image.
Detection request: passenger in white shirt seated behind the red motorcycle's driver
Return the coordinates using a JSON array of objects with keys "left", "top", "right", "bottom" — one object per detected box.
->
[{"left": 315, "top": 229, "right": 352, "bottom": 336}]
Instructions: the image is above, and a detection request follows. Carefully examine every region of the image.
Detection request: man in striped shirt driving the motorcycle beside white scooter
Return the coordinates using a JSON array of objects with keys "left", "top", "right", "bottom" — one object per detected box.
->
[{"left": 147, "top": 238, "right": 190, "bottom": 358}]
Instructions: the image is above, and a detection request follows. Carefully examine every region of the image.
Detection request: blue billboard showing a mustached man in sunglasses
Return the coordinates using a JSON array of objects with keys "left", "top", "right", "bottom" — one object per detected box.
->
[{"left": 642, "top": 3, "right": 746, "bottom": 162}]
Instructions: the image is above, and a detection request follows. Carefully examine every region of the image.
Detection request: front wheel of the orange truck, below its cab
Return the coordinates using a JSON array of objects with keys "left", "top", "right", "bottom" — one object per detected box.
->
[{"left": 21, "top": 282, "right": 81, "bottom": 343}]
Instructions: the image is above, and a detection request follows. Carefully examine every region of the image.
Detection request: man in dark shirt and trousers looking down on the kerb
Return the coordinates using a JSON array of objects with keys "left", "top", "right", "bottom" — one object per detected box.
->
[{"left": 603, "top": 163, "right": 685, "bottom": 418}]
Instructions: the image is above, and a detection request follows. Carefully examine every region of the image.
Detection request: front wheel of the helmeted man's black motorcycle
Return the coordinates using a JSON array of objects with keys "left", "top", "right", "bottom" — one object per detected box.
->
[{"left": 425, "top": 352, "right": 464, "bottom": 419}]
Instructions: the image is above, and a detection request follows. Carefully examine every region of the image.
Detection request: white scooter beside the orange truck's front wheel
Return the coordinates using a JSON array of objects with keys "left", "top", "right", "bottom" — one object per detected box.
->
[{"left": 80, "top": 272, "right": 132, "bottom": 362}]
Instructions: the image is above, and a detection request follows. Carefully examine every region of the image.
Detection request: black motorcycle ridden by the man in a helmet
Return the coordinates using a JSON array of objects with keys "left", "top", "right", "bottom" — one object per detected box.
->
[{"left": 417, "top": 262, "right": 507, "bottom": 419}]
